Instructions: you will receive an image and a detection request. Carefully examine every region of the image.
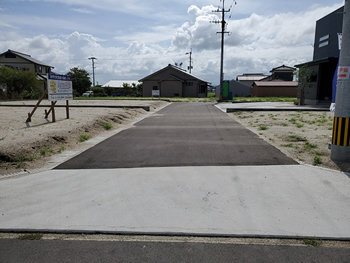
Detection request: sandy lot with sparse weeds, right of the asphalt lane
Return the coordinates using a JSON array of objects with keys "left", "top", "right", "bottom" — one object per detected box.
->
[{"left": 229, "top": 111, "right": 350, "bottom": 172}]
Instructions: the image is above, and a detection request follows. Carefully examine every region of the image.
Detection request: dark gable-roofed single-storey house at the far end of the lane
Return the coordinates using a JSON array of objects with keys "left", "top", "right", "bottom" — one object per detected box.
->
[{"left": 139, "top": 64, "right": 208, "bottom": 98}]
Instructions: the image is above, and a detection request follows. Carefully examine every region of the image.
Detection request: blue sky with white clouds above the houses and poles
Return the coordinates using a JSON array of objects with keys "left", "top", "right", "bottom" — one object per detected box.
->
[{"left": 0, "top": 0, "right": 344, "bottom": 85}]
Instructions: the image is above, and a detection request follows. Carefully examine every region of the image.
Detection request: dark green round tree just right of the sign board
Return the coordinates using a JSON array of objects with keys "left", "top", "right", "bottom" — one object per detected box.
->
[{"left": 67, "top": 67, "right": 91, "bottom": 96}]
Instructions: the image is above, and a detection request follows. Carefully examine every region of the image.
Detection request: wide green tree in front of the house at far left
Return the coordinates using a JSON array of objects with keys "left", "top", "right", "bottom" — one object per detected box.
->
[{"left": 0, "top": 66, "right": 40, "bottom": 99}]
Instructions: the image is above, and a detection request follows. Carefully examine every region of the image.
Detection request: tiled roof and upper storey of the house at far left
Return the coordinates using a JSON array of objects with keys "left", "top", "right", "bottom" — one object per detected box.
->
[{"left": 0, "top": 49, "right": 54, "bottom": 75}]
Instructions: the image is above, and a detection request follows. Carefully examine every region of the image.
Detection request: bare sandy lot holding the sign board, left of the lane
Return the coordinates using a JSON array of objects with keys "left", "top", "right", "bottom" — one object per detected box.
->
[{"left": 0, "top": 100, "right": 167, "bottom": 175}]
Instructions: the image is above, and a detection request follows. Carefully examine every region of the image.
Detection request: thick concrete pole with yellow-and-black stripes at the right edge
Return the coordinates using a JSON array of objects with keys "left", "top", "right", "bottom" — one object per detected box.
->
[{"left": 331, "top": 0, "right": 350, "bottom": 163}]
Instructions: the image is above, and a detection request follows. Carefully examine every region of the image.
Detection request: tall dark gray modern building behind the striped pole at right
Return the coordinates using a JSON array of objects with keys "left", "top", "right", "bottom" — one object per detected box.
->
[{"left": 296, "top": 7, "right": 344, "bottom": 105}]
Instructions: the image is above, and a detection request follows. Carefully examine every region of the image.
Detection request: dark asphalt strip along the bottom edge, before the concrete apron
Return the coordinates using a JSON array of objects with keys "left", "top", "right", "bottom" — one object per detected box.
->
[{"left": 0, "top": 239, "right": 350, "bottom": 263}]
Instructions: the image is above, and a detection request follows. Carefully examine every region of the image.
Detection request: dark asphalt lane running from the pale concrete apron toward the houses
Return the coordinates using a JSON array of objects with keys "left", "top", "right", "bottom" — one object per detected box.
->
[{"left": 56, "top": 103, "right": 297, "bottom": 169}]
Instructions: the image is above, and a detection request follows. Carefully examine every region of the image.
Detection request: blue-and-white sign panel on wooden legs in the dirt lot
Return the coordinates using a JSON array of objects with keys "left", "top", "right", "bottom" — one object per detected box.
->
[{"left": 47, "top": 73, "right": 73, "bottom": 101}]
